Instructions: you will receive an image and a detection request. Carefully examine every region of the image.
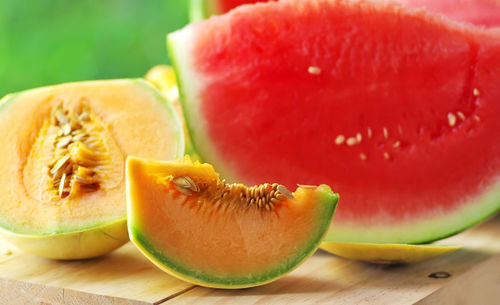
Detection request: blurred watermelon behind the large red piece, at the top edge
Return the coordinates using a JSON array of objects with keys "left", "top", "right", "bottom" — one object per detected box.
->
[{"left": 190, "top": 0, "right": 500, "bottom": 26}]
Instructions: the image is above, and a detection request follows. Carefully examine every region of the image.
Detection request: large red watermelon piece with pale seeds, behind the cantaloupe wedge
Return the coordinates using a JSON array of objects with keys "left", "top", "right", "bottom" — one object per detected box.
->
[{"left": 168, "top": 0, "right": 500, "bottom": 243}]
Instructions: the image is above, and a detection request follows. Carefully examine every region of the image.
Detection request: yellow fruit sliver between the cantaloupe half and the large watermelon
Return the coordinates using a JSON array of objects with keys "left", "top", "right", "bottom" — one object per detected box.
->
[{"left": 145, "top": 65, "right": 200, "bottom": 160}]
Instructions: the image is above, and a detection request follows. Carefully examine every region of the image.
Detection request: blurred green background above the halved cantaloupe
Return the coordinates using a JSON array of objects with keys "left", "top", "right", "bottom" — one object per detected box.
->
[{"left": 0, "top": 0, "right": 188, "bottom": 97}]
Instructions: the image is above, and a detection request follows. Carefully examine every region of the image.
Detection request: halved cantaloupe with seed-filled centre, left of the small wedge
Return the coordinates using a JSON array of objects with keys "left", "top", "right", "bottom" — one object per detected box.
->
[{"left": 0, "top": 80, "right": 184, "bottom": 259}]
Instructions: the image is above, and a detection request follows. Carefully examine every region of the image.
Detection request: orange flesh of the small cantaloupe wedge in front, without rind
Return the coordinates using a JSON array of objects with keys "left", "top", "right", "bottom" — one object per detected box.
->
[{"left": 127, "top": 158, "right": 326, "bottom": 278}]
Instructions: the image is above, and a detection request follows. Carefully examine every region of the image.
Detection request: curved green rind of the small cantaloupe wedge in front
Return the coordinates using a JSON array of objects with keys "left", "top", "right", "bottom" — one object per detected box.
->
[{"left": 127, "top": 176, "right": 339, "bottom": 289}]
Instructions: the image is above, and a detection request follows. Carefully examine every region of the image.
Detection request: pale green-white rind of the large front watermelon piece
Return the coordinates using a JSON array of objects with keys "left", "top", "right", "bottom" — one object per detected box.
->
[{"left": 167, "top": 26, "right": 500, "bottom": 244}]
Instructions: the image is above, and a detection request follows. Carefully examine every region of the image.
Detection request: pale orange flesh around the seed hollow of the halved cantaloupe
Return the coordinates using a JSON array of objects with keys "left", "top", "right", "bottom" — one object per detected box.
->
[{"left": 0, "top": 80, "right": 184, "bottom": 236}]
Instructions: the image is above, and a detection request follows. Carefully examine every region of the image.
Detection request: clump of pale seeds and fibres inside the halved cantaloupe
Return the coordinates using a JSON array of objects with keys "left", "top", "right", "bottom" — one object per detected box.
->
[{"left": 37, "top": 104, "right": 111, "bottom": 199}]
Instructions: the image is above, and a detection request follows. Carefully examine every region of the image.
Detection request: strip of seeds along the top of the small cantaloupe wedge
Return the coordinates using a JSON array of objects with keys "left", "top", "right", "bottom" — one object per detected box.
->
[{"left": 163, "top": 175, "right": 300, "bottom": 211}]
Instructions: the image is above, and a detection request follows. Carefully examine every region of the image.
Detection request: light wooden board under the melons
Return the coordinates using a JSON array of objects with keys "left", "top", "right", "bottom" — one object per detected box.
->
[{"left": 0, "top": 215, "right": 500, "bottom": 305}]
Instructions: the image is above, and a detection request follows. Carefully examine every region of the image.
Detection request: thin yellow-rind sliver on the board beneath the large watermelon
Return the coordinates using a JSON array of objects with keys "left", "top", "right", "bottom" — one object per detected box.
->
[{"left": 320, "top": 241, "right": 460, "bottom": 264}]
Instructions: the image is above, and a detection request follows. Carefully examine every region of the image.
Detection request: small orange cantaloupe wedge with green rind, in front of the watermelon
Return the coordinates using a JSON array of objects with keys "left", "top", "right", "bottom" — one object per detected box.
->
[{"left": 127, "top": 157, "right": 338, "bottom": 288}]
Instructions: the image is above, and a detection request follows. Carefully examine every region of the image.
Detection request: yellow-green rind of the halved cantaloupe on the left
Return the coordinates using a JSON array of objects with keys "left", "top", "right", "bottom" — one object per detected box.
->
[{"left": 0, "top": 79, "right": 184, "bottom": 260}]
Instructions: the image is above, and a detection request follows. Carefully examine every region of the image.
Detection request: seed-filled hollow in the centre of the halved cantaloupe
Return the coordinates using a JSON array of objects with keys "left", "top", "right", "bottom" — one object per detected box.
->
[{"left": 24, "top": 98, "right": 123, "bottom": 203}]
